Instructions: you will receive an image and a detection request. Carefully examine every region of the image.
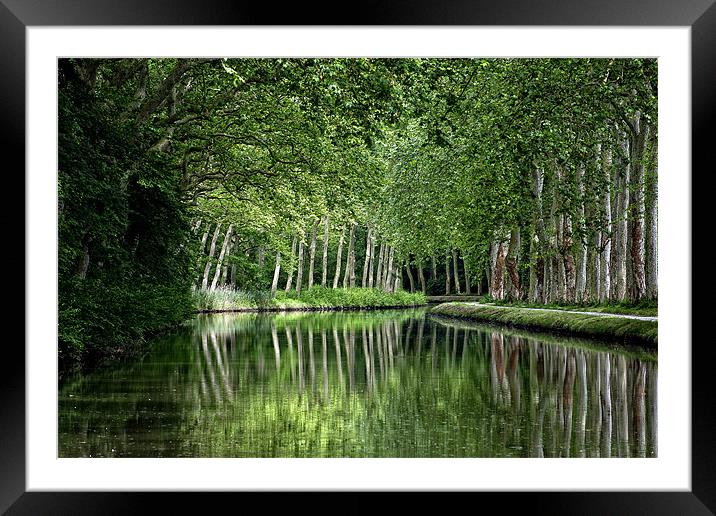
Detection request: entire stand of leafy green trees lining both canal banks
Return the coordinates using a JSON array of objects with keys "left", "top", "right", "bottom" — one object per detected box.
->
[{"left": 58, "top": 58, "right": 658, "bottom": 362}]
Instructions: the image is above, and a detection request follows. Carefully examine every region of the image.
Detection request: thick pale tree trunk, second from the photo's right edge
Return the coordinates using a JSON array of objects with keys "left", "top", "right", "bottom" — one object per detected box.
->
[{"left": 628, "top": 111, "right": 649, "bottom": 302}]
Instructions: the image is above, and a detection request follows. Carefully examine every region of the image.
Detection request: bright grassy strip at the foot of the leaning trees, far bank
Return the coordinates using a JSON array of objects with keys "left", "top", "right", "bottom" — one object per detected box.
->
[{"left": 194, "top": 287, "right": 426, "bottom": 311}]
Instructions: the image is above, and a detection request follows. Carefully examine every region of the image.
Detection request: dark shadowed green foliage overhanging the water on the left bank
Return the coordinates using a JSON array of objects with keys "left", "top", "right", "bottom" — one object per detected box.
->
[{"left": 58, "top": 60, "right": 191, "bottom": 362}]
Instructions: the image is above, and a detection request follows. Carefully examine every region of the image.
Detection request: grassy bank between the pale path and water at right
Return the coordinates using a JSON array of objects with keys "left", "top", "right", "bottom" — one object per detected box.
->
[{"left": 430, "top": 303, "right": 658, "bottom": 348}]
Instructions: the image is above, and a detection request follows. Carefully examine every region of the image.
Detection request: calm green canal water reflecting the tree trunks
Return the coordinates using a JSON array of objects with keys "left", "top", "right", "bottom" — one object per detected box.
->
[{"left": 59, "top": 309, "right": 657, "bottom": 457}]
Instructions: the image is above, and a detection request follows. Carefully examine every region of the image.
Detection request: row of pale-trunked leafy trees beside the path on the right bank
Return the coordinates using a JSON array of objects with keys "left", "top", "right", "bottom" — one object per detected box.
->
[{"left": 382, "top": 59, "right": 658, "bottom": 303}]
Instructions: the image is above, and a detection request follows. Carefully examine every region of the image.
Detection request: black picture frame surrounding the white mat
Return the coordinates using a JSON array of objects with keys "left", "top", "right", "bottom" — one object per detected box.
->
[{"left": 5, "top": 0, "right": 716, "bottom": 515}]
